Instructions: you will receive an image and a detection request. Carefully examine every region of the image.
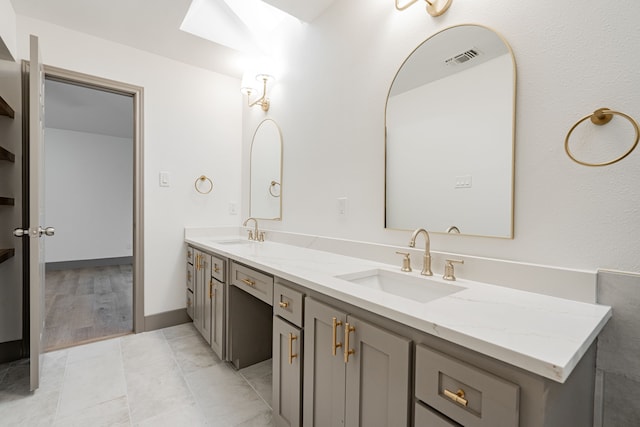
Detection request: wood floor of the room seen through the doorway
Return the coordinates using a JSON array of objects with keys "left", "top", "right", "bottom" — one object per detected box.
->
[{"left": 44, "top": 265, "right": 133, "bottom": 351}]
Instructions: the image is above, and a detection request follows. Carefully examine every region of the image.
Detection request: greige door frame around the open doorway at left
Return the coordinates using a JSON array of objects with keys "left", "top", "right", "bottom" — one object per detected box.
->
[{"left": 22, "top": 61, "right": 145, "bottom": 354}]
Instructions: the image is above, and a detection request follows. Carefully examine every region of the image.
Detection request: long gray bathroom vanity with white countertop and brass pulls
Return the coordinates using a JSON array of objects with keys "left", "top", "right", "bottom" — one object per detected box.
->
[{"left": 186, "top": 236, "right": 611, "bottom": 427}]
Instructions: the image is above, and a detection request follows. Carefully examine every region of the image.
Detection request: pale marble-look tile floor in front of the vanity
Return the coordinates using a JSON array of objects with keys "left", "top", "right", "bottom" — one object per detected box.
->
[{"left": 0, "top": 323, "right": 273, "bottom": 427}]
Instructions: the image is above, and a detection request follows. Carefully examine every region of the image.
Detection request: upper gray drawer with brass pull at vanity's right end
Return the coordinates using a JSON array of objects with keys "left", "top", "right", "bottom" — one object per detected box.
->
[{"left": 415, "top": 346, "right": 520, "bottom": 427}]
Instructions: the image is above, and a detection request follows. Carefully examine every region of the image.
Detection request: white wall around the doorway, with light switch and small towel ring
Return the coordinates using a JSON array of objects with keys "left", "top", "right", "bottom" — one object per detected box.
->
[{"left": 17, "top": 15, "right": 242, "bottom": 316}]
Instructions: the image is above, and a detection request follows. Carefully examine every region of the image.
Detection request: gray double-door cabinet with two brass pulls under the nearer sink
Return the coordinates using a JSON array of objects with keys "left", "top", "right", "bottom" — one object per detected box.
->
[{"left": 303, "top": 298, "right": 411, "bottom": 427}]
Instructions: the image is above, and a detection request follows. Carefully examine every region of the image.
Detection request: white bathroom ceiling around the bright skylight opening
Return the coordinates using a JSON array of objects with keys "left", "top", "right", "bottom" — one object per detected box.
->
[{"left": 11, "top": 0, "right": 335, "bottom": 78}]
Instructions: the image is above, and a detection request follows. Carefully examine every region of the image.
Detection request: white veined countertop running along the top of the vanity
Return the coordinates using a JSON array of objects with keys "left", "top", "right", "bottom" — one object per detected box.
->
[{"left": 185, "top": 236, "right": 612, "bottom": 382}]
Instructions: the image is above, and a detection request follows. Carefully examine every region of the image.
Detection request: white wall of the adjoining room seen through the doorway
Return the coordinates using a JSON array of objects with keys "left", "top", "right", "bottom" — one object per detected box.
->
[{"left": 45, "top": 127, "right": 133, "bottom": 262}]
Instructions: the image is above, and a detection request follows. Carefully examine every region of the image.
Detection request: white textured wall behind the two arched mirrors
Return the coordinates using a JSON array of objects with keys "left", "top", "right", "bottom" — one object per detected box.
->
[{"left": 243, "top": 0, "right": 640, "bottom": 272}]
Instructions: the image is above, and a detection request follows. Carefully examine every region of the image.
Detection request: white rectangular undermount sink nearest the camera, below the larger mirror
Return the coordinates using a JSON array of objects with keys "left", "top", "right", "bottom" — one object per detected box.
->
[{"left": 336, "top": 269, "right": 466, "bottom": 303}]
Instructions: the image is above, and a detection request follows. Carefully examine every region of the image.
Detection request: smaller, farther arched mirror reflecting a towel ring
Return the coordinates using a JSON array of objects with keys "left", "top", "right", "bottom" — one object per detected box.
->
[{"left": 249, "top": 119, "right": 282, "bottom": 219}]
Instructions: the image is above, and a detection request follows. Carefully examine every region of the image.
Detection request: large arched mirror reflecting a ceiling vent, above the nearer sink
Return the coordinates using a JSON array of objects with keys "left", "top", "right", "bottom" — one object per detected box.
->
[{"left": 385, "top": 25, "right": 516, "bottom": 238}]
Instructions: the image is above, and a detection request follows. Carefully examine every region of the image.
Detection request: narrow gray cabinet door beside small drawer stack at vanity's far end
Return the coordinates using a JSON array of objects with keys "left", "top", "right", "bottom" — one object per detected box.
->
[{"left": 193, "top": 249, "right": 213, "bottom": 343}]
